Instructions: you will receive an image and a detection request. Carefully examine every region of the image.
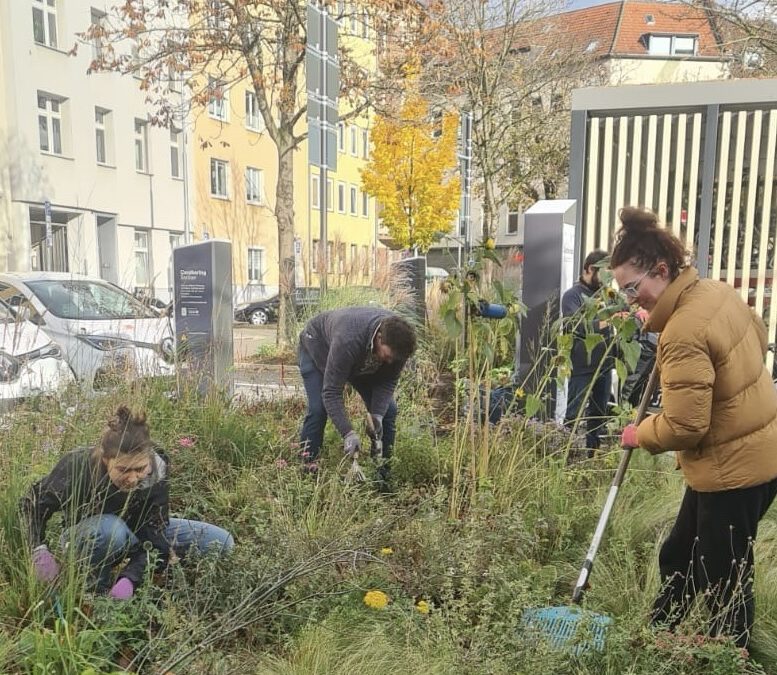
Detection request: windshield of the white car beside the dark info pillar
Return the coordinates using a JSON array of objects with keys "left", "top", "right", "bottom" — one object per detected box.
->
[{"left": 27, "top": 279, "right": 157, "bottom": 321}]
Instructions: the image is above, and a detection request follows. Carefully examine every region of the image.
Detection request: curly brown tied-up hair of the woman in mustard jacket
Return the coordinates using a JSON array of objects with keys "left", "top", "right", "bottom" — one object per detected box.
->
[{"left": 610, "top": 206, "right": 688, "bottom": 279}]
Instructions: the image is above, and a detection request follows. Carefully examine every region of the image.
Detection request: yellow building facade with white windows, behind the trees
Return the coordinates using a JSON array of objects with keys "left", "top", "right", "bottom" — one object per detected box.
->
[{"left": 191, "top": 9, "right": 378, "bottom": 303}]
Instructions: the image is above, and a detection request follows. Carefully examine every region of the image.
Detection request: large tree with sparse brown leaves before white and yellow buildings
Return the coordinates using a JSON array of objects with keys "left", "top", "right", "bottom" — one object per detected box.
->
[{"left": 81, "top": 0, "right": 415, "bottom": 340}]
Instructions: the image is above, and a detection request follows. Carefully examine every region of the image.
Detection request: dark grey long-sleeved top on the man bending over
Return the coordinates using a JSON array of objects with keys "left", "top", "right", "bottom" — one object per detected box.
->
[{"left": 300, "top": 307, "right": 405, "bottom": 436}]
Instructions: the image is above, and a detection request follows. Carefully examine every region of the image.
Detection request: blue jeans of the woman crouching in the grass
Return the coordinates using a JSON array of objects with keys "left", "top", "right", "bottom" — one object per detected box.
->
[{"left": 62, "top": 514, "right": 235, "bottom": 592}]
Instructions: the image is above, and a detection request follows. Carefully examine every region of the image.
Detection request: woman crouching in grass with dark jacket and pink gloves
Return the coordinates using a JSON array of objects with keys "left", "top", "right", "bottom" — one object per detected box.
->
[{"left": 21, "top": 406, "right": 234, "bottom": 600}]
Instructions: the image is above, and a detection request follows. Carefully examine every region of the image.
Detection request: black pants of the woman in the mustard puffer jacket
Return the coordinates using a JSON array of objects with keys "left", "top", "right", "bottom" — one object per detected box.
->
[{"left": 652, "top": 479, "right": 777, "bottom": 647}]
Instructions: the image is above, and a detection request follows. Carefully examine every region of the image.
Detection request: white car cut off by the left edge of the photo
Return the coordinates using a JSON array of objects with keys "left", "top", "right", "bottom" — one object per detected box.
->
[{"left": 0, "top": 303, "right": 75, "bottom": 408}]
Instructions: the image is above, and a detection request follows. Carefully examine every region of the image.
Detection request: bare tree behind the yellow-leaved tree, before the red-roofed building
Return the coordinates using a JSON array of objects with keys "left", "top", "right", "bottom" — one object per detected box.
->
[{"left": 416, "top": 0, "right": 593, "bottom": 239}]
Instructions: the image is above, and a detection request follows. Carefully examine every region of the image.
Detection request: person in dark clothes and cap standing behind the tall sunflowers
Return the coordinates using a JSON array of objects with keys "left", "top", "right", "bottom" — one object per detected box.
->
[{"left": 561, "top": 250, "right": 613, "bottom": 457}]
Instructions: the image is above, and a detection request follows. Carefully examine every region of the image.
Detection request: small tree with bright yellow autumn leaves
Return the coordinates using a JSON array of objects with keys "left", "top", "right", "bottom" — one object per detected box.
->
[{"left": 361, "top": 93, "right": 461, "bottom": 252}]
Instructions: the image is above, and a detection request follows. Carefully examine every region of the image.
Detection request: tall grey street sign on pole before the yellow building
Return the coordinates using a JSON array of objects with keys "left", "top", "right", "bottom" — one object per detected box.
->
[{"left": 305, "top": 3, "right": 340, "bottom": 291}]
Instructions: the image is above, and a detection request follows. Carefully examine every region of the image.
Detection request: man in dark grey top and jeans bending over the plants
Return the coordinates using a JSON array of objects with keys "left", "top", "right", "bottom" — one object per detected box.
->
[{"left": 299, "top": 307, "right": 416, "bottom": 483}]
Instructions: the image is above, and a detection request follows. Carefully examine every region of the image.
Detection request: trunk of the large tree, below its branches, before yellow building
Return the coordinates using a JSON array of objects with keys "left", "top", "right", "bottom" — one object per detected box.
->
[{"left": 275, "top": 137, "right": 295, "bottom": 345}]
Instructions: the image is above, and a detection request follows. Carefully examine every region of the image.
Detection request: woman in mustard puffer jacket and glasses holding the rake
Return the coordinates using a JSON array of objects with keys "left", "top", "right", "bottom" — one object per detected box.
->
[{"left": 610, "top": 207, "right": 777, "bottom": 647}]
